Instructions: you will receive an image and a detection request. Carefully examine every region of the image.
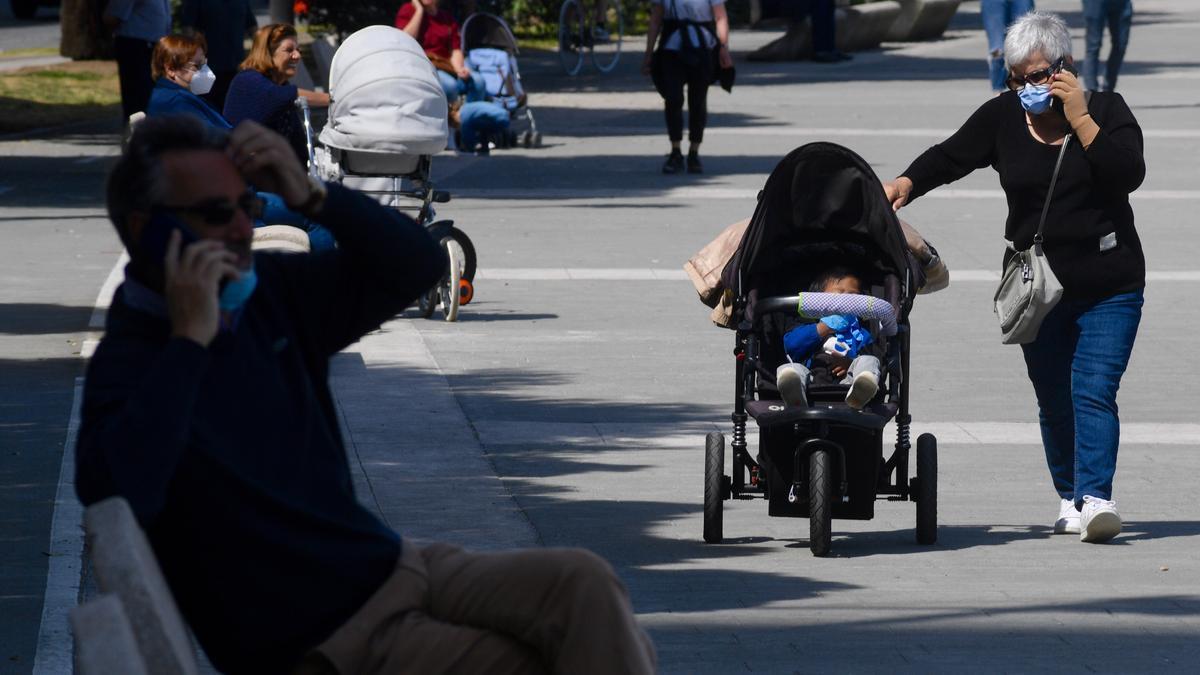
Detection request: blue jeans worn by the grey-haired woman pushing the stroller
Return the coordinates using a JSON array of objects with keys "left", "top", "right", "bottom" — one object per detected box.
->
[{"left": 1022, "top": 291, "right": 1144, "bottom": 507}]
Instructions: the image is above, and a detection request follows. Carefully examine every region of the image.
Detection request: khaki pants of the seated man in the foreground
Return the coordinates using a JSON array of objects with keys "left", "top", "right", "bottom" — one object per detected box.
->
[{"left": 296, "top": 542, "right": 655, "bottom": 675}]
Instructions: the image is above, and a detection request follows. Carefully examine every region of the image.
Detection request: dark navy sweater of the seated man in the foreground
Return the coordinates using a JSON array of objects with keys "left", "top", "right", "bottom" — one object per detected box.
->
[{"left": 76, "top": 186, "right": 446, "bottom": 673}]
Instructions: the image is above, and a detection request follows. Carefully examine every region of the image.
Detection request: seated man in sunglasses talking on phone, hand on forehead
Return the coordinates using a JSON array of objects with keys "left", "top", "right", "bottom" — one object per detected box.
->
[{"left": 76, "top": 117, "right": 654, "bottom": 675}]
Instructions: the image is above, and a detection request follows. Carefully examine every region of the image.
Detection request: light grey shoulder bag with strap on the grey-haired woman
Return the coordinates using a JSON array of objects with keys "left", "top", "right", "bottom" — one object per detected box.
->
[{"left": 994, "top": 133, "right": 1070, "bottom": 345}]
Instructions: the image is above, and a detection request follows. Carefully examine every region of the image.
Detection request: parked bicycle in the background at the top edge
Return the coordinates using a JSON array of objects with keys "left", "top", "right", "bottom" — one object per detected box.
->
[{"left": 558, "top": 0, "right": 625, "bottom": 76}]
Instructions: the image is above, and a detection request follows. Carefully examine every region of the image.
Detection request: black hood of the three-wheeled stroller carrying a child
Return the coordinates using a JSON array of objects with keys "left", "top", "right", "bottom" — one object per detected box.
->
[{"left": 721, "top": 142, "right": 920, "bottom": 313}]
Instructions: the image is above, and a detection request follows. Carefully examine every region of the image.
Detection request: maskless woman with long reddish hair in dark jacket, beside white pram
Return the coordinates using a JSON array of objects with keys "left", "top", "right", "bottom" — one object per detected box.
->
[{"left": 224, "top": 24, "right": 329, "bottom": 165}]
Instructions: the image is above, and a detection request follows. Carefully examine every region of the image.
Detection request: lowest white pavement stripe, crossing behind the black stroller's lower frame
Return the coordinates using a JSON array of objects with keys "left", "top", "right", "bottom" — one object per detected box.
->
[{"left": 473, "top": 419, "right": 1200, "bottom": 444}]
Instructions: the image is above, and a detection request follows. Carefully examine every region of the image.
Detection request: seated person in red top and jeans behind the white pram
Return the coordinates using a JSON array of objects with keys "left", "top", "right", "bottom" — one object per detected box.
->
[{"left": 396, "top": 0, "right": 487, "bottom": 103}]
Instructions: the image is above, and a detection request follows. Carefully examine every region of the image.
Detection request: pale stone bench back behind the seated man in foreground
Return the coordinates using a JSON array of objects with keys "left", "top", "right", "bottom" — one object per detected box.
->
[{"left": 71, "top": 497, "right": 199, "bottom": 675}]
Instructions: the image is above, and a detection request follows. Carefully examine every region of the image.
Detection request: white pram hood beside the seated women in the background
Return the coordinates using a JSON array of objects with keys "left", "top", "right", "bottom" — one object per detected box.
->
[{"left": 320, "top": 25, "right": 448, "bottom": 155}]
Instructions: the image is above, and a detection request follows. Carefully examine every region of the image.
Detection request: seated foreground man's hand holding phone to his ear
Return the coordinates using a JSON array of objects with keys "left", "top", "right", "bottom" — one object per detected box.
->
[{"left": 162, "top": 229, "right": 240, "bottom": 347}]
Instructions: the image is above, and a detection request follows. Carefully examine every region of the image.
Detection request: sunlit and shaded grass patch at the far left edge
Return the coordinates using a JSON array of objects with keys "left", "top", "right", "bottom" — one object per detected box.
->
[{"left": 0, "top": 61, "right": 121, "bottom": 133}]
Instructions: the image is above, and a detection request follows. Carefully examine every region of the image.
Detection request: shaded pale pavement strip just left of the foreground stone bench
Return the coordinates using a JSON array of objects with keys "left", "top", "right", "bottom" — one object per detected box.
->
[{"left": 34, "top": 377, "right": 83, "bottom": 675}]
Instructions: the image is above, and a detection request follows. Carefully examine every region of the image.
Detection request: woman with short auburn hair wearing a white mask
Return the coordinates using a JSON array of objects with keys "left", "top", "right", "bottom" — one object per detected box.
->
[{"left": 146, "top": 34, "right": 232, "bottom": 129}]
